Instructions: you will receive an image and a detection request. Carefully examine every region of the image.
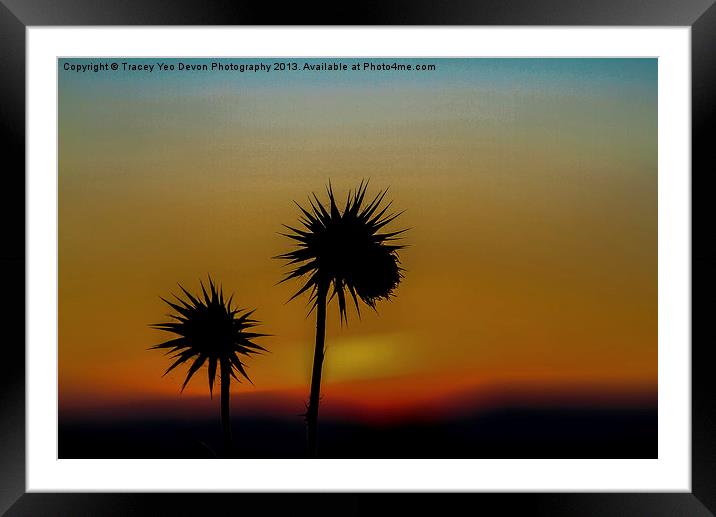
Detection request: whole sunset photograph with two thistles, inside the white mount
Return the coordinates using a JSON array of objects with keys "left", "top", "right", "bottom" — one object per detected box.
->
[{"left": 56, "top": 57, "right": 659, "bottom": 460}]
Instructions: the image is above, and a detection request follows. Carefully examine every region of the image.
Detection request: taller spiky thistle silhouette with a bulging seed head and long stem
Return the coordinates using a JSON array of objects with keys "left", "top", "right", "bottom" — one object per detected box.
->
[{"left": 274, "top": 181, "right": 406, "bottom": 457}]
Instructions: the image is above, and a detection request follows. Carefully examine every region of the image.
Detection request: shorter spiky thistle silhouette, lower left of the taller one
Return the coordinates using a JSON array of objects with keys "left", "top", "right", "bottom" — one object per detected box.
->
[{"left": 150, "top": 277, "right": 268, "bottom": 455}]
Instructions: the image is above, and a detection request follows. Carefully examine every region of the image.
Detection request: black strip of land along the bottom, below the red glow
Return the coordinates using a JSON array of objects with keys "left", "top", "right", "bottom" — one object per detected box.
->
[{"left": 59, "top": 408, "right": 657, "bottom": 458}]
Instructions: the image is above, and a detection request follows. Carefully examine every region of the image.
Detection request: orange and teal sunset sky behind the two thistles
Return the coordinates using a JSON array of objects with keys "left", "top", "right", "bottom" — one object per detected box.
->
[{"left": 59, "top": 59, "right": 657, "bottom": 419}]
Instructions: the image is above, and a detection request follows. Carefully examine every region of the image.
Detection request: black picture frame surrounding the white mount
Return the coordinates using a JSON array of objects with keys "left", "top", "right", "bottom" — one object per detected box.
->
[{"left": 0, "top": 0, "right": 716, "bottom": 517}]
